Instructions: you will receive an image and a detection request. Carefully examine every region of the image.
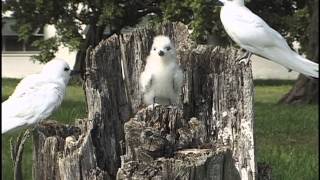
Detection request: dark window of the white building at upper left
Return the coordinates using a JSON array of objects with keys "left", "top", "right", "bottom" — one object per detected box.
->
[{"left": 1, "top": 18, "right": 44, "bottom": 53}]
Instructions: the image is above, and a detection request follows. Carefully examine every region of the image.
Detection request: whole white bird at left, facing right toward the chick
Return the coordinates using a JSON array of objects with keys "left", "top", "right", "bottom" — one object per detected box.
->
[{"left": 1, "top": 59, "right": 71, "bottom": 134}]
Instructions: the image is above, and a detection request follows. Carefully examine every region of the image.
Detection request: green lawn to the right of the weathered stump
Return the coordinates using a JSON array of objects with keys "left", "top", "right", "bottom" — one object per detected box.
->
[{"left": 255, "top": 81, "right": 319, "bottom": 180}]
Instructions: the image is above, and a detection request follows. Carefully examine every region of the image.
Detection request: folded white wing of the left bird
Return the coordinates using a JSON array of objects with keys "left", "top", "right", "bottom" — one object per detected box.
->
[{"left": 2, "top": 84, "right": 62, "bottom": 133}]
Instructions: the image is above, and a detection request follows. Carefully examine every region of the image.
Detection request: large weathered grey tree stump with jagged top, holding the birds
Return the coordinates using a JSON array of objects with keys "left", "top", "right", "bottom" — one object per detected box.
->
[{"left": 34, "top": 23, "right": 256, "bottom": 180}]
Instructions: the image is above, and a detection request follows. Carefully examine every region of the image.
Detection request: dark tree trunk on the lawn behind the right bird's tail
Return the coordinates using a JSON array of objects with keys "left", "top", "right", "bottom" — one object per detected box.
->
[{"left": 280, "top": 0, "right": 319, "bottom": 104}]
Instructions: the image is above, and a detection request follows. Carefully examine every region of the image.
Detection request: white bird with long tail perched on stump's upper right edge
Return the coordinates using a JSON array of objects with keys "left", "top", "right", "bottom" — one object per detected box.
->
[{"left": 219, "top": 0, "right": 319, "bottom": 78}]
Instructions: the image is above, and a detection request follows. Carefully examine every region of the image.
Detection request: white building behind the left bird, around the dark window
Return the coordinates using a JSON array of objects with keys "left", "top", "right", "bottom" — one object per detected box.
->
[{"left": 1, "top": 17, "right": 76, "bottom": 78}]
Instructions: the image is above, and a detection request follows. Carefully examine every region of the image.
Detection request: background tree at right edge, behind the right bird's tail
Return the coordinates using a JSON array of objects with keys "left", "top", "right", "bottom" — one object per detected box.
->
[{"left": 280, "top": 0, "right": 319, "bottom": 104}]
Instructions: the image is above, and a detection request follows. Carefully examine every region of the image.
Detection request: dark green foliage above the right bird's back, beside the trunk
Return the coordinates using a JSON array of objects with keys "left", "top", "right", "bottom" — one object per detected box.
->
[{"left": 247, "top": 0, "right": 310, "bottom": 53}]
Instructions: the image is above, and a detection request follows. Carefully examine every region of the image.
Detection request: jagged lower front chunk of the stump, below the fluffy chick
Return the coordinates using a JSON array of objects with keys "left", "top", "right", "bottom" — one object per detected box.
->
[{"left": 117, "top": 106, "right": 240, "bottom": 180}]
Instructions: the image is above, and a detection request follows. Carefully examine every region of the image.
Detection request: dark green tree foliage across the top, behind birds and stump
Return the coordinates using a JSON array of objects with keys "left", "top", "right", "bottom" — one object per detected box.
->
[{"left": 2, "top": 0, "right": 309, "bottom": 62}]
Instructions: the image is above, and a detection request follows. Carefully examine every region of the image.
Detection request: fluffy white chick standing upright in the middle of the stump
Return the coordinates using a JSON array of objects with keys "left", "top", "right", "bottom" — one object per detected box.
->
[{"left": 140, "top": 35, "right": 183, "bottom": 105}]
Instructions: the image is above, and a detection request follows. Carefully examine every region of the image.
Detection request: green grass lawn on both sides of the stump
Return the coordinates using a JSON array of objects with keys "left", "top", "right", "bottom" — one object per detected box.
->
[{"left": 2, "top": 79, "right": 319, "bottom": 180}]
